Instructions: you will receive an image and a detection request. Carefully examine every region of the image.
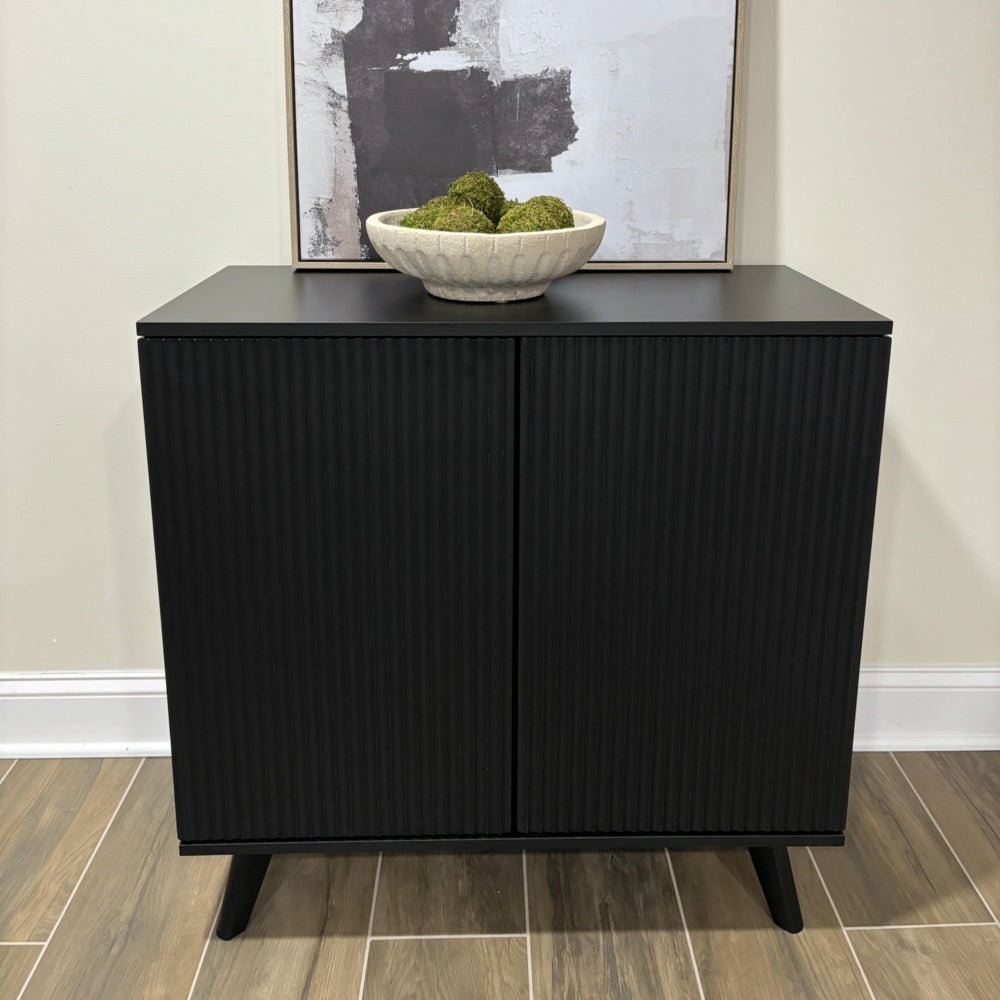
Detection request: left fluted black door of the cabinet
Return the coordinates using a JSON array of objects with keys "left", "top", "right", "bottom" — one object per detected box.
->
[{"left": 139, "top": 337, "right": 515, "bottom": 842}]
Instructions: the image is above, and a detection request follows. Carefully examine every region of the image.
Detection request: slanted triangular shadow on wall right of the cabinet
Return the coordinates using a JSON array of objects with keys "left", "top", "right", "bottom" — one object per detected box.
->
[{"left": 861, "top": 422, "right": 1000, "bottom": 665}]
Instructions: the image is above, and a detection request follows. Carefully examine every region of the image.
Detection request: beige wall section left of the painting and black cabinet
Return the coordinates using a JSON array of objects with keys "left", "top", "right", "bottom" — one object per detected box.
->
[{"left": 0, "top": 0, "right": 290, "bottom": 671}]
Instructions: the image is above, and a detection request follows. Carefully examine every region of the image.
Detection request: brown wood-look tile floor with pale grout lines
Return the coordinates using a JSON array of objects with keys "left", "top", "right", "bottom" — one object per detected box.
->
[{"left": 0, "top": 752, "right": 1000, "bottom": 1000}]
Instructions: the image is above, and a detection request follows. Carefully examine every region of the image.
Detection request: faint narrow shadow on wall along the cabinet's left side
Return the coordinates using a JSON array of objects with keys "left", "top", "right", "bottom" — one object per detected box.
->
[{"left": 104, "top": 390, "right": 163, "bottom": 670}]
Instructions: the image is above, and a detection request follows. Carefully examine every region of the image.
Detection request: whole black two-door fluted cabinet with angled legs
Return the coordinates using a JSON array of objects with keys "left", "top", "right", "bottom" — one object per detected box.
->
[{"left": 138, "top": 266, "right": 891, "bottom": 937}]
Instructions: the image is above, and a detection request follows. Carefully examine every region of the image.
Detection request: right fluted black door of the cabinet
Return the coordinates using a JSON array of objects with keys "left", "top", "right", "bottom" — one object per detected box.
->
[{"left": 517, "top": 336, "right": 889, "bottom": 833}]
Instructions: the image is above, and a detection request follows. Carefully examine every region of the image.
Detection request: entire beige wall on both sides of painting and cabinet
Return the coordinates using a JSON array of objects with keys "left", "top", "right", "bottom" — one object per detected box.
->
[{"left": 0, "top": 0, "right": 1000, "bottom": 671}]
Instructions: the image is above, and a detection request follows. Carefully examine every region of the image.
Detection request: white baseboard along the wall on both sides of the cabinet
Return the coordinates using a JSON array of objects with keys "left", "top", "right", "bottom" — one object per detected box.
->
[{"left": 0, "top": 665, "right": 1000, "bottom": 757}]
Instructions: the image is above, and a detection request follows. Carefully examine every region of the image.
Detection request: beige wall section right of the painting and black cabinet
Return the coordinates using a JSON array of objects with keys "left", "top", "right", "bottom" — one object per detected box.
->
[{"left": 738, "top": 0, "right": 1000, "bottom": 664}]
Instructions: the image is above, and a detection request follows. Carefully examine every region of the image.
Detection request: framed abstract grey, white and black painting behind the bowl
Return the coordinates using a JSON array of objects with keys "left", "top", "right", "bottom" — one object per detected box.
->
[{"left": 290, "top": 0, "right": 739, "bottom": 266}]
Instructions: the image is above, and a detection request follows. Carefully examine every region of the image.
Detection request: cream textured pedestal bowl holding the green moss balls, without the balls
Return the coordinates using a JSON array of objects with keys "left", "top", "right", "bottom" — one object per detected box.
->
[{"left": 365, "top": 208, "right": 604, "bottom": 302}]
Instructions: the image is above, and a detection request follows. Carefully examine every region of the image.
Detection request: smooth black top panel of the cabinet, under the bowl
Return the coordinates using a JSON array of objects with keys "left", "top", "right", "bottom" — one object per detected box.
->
[{"left": 137, "top": 264, "right": 892, "bottom": 337}]
